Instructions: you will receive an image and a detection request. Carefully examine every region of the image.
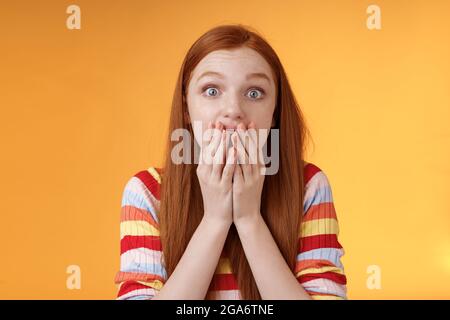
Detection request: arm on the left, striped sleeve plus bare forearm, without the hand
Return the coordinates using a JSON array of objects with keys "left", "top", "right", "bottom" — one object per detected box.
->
[{"left": 115, "top": 170, "right": 231, "bottom": 300}]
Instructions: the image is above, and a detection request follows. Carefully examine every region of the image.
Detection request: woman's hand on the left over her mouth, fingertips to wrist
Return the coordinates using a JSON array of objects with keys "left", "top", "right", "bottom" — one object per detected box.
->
[{"left": 197, "top": 122, "right": 236, "bottom": 225}]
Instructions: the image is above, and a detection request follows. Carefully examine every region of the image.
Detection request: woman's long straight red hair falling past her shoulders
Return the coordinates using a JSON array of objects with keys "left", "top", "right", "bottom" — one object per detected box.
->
[{"left": 159, "top": 25, "right": 308, "bottom": 300}]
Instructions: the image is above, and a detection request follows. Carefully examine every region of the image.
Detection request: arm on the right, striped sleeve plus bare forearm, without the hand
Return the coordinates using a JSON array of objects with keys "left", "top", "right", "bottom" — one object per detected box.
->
[{"left": 234, "top": 158, "right": 347, "bottom": 299}]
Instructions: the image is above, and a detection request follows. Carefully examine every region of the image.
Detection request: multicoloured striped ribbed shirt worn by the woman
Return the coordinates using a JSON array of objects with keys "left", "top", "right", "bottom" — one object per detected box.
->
[{"left": 115, "top": 163, "right": 347, "bottom": 300}]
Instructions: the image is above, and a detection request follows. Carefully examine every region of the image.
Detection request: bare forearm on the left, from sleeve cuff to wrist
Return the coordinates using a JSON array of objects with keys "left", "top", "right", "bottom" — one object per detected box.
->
[{"left": 153, "top": 218, "right": 230, "bottom": 300}]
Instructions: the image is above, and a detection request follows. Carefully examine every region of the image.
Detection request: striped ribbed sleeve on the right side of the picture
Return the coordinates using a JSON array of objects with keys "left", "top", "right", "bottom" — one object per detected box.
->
[{"left": 295, "top": 164, "right": 347, "bottom": 300}]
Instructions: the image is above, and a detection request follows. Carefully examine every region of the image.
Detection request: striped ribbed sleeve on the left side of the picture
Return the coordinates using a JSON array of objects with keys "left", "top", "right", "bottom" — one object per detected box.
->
[{"left": 115, "top": 168, "right": 167, "bottom": 300}]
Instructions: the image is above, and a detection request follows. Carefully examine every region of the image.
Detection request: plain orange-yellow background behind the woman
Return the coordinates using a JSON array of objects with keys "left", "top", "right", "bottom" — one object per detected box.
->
[{"left": 0, "top": 0, "right": 450, "bottom": 299}]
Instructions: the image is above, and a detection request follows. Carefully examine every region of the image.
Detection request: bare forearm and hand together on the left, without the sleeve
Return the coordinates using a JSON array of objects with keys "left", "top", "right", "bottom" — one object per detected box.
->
[{"left": 155, "top": 123, "right": 234, "bottom": 300}]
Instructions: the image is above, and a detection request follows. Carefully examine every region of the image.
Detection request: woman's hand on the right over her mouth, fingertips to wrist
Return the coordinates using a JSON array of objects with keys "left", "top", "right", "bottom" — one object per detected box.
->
[{"left": 232, "top": 122, "right": 265, "bottom": 226}]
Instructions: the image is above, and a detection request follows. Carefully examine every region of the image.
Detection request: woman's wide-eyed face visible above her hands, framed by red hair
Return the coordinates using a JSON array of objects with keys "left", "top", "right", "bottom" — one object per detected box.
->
[{"left": 186, "top": 47, "right": 276, "bottom": 145}]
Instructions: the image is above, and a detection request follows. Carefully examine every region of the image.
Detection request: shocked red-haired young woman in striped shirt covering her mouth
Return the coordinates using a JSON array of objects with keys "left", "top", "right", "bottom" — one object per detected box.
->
[{"left": 115, "top": 25, "right": 347, "bottom": 300}]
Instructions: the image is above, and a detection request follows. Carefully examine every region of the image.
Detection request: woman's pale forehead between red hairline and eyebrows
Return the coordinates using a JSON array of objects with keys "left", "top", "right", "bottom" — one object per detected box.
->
[{"left": 192, "top": 47, "right": 273, "bottom": 81}]
